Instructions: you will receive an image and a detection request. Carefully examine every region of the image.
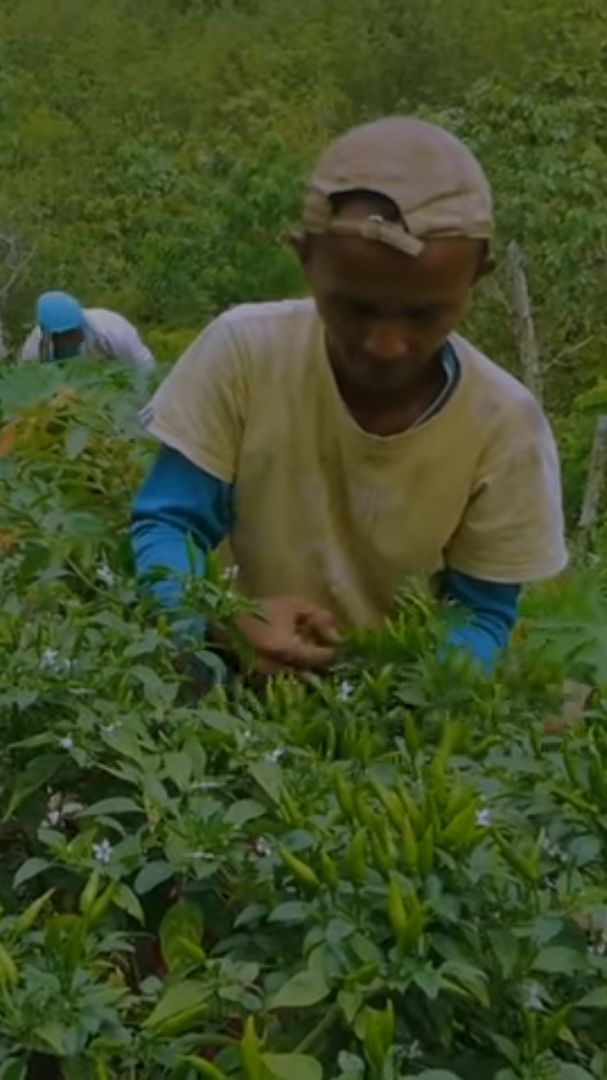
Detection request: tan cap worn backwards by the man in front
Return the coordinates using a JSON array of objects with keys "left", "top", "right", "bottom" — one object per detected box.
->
[{"left": 302, "top": 117, "right": 493, "bottom": 255}]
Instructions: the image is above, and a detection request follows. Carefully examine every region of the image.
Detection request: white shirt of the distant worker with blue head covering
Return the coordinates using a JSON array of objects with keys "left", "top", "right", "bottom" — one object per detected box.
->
[{"left": 21, "top": 308, "right": 154, "bottom": 372}]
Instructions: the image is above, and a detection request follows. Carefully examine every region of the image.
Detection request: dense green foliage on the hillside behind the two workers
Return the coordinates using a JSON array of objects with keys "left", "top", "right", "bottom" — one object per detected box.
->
[{"left": 0, "top": 0, "right": 607, "bottom": 404}]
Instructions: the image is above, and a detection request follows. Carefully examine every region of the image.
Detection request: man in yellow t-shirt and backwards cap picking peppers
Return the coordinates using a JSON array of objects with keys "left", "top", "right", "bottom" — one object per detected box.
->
[{"left": 133, "top": 117, "right": 566, "bottom": 671}]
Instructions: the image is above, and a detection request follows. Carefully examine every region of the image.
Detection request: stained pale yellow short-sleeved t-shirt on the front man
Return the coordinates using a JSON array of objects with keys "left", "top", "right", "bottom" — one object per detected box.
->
[{"left": 143, "top": 300, "right": 567, "bottom": 626}]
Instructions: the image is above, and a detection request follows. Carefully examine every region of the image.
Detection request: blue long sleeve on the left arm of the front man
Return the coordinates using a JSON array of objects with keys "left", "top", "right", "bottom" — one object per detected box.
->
[{"left": 131, "top": 446, "right": 232, "bottom": 622}]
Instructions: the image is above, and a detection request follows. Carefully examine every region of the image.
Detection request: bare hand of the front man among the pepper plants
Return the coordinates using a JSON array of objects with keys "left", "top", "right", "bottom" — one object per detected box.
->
[{"left": 237, "top": 596, "right": 339, "bottom": 675}]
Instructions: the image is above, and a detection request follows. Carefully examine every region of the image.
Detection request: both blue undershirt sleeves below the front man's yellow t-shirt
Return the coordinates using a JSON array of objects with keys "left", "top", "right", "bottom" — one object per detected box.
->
[{"left": 131, "top": 446, "right": 521, "bottom": 672}]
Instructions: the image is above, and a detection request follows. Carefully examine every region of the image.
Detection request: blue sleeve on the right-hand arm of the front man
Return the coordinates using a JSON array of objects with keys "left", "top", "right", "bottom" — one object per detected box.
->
[{"left": 442, "top": 569, "right": 522, "bottom": 674}]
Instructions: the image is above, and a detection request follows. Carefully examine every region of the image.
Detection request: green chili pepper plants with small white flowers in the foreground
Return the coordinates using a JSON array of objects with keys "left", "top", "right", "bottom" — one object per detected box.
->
[{"left": 0, "top": 365, "right": 607, "bottom": 1080}]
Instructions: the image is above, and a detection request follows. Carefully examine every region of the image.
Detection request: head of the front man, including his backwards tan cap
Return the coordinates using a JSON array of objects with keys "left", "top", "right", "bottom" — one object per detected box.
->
[{"left": 296, "top": 117, "right": 493, "bottom": 394}]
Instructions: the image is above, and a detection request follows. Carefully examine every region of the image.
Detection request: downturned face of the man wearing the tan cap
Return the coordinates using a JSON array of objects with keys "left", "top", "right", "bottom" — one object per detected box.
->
[{"left": 300, "top": 226, "right": 485, "bottom": 394}]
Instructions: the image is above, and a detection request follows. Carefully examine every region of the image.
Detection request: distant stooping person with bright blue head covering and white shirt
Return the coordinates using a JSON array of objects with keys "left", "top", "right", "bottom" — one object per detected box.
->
[{"left": 21, "top": 293, "right": 154, "bottom": 372}]
